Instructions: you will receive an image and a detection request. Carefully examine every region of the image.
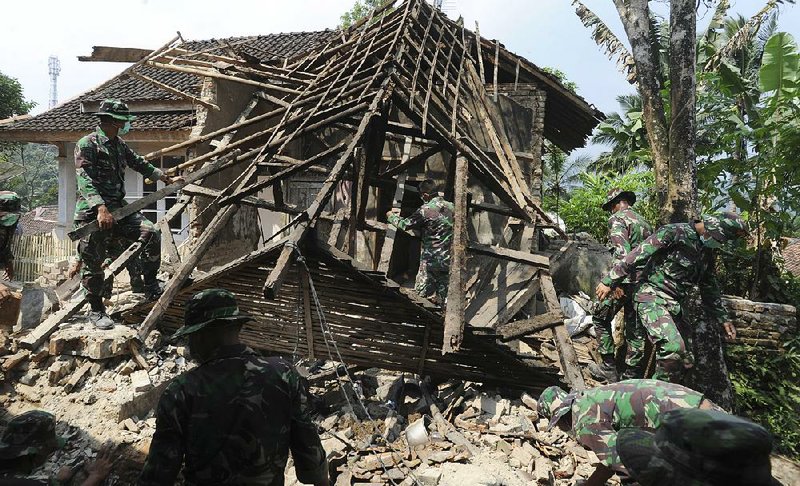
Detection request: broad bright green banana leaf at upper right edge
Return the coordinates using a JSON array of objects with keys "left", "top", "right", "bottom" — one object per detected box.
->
[{"left": 759, "top": 32, "right": 800, "bottom": 95}]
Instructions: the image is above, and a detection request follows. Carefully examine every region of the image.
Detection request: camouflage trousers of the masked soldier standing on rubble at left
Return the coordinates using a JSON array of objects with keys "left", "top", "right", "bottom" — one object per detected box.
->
[{"left": 75, "top": 213, "right": 161, "bottom": 310}]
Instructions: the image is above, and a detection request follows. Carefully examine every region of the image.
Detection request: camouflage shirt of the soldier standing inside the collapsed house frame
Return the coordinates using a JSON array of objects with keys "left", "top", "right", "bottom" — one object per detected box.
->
[{"left": 389, "top": 196, "right": 454, "bottom": 267}]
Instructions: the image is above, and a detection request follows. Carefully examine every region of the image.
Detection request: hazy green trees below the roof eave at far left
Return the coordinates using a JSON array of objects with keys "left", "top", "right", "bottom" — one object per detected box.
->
[{"left": 0, "top": 143, "right": 58, "bottom": 210}]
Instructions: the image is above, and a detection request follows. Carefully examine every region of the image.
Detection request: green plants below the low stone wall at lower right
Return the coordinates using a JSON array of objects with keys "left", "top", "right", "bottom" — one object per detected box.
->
[{"left": 727, "top": 336, "right": 800, "bottom": 459}]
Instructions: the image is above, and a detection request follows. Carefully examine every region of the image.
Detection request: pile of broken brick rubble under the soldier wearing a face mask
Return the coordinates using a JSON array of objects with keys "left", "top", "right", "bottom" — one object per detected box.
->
[{"left": 0, "top": 308, "right": 194, "bottom": 484}]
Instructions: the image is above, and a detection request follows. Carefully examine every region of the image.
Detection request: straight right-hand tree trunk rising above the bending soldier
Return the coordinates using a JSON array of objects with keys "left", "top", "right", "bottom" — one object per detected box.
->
[{"left": 662, "top": 0, "right": 697, "bottom": 223}]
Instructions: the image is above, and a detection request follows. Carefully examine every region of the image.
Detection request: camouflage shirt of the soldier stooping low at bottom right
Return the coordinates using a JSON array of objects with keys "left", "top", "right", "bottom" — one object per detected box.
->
[{"left": 572, "top": 380, "right": 703, "bottom": 471}]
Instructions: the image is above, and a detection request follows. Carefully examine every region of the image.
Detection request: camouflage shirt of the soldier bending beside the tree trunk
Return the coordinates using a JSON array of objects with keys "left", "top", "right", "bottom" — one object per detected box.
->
[{"left": 602, "top": 223, "right": 728, "bottom": 323}]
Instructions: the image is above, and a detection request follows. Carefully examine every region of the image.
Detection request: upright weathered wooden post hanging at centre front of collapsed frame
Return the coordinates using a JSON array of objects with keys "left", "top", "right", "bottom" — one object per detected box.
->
[{"left": 442, "top": 154, "right": 469, "bottom": 354}]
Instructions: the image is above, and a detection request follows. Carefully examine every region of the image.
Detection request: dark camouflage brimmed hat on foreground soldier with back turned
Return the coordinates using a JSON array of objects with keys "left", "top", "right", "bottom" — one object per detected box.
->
[{"left": 172, "top": 289, "right": 253, "bottom": 339}]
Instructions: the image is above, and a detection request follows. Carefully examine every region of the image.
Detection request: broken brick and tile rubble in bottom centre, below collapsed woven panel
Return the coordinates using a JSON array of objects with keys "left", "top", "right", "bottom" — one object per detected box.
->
[{"left": 287, "top": 363, "right": 612, "bottom": 486}]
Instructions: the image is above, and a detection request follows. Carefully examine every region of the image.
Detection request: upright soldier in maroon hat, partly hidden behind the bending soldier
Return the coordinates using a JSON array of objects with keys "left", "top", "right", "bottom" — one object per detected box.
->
[{"left": 589, "top": 188, "right": 653, "bottom": 383}]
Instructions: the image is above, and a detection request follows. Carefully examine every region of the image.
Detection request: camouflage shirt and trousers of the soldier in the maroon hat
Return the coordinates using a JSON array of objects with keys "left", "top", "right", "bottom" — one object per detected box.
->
[{"left": 592, "top": 208, "right": 653, "bottom": 378}]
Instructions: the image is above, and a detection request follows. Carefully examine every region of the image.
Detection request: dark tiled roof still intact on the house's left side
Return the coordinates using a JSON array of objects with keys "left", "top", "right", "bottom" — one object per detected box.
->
[{"left": 0, "top": 30, "right": 336, "bottom": 134}]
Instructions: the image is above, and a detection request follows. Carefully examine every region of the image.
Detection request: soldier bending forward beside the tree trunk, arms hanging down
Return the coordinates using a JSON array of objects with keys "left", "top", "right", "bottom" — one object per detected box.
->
[{"left": 596, "top": 212, "right": 747, "bottom": 383}]
